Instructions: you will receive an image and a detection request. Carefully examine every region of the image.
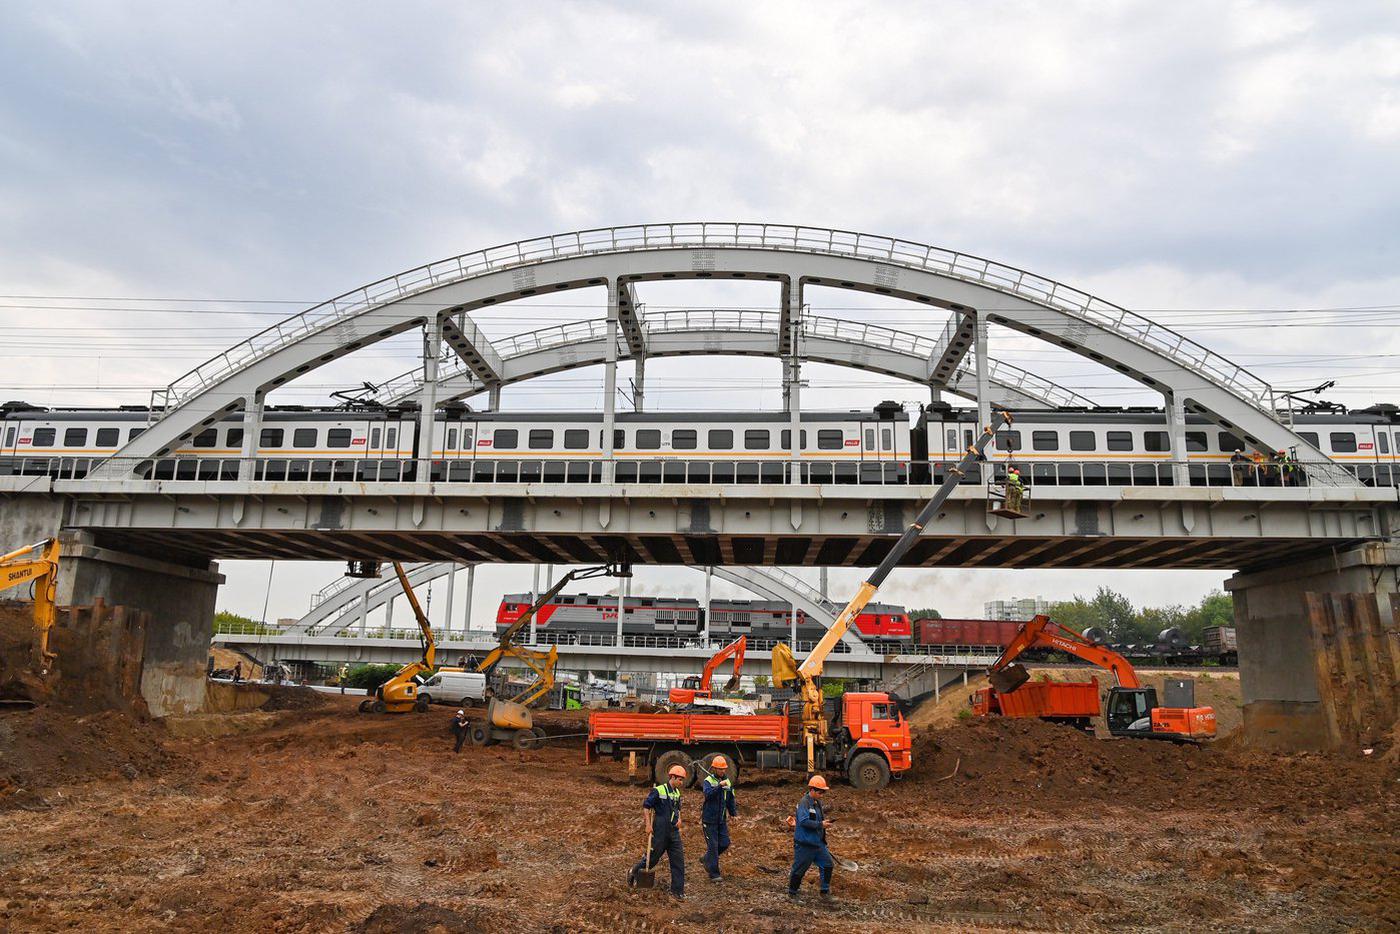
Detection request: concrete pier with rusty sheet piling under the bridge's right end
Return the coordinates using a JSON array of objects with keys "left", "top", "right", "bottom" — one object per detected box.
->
[{"left": 1225, "top": 539, "right": 1400, "bottom": 752}]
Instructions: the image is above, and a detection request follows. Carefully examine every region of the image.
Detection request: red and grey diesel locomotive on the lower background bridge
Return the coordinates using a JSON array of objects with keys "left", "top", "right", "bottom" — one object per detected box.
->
[{"left": 496, "top": 594, "right": 913, "bottom": 643}]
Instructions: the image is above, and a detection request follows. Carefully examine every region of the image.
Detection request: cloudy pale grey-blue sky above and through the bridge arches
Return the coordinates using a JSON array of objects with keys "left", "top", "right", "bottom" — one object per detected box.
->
[{"left": 0, "top": 0, "right": 1400, "bottom": 627}]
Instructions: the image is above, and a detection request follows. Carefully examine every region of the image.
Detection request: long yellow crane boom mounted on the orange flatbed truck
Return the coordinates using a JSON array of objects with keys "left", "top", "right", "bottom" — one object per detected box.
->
[{"left": 773, "top": 412, "right": 1011, "bottom": 772}]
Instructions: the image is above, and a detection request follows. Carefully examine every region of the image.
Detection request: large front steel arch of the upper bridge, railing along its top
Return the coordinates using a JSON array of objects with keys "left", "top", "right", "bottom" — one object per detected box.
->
[{"left": 94, "top": 221, "right": 1327, "bottom": 478}]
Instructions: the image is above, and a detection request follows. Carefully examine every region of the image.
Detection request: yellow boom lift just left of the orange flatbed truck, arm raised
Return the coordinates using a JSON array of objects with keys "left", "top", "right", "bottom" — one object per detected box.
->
[{"left": 466, "top": 564, "right": 631, "bottom": 749}]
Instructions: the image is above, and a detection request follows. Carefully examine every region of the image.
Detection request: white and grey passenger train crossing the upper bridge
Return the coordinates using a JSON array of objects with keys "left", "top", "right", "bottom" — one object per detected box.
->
[{"left": 0, "top": 402, "right": 1400, "bottom": 486}]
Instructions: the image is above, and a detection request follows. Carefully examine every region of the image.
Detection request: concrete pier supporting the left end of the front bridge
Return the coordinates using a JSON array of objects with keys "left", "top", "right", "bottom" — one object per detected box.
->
[{"left": 57, "top": 532, "right": 224, "bottom": 717}]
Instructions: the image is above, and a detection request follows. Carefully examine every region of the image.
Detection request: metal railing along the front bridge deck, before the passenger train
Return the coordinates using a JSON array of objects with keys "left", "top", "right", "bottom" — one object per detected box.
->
[{"left": 13, "top": 455, "right": 1400, "bottom": 489}]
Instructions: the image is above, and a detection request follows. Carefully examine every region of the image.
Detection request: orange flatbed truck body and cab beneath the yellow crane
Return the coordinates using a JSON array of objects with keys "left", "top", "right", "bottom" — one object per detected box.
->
[{"left": 584, "top": 692, "right": 911, "bottom": 788}]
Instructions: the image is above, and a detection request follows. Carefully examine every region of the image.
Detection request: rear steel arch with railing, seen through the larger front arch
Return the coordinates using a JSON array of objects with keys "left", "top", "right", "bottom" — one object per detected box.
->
[{"left": 379, "top": 308, "right": 1093, "bottom": 409}]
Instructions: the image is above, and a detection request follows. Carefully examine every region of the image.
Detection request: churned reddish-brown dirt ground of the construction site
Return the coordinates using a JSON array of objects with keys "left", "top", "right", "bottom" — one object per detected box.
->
[{"left": 0, "top": 695, "right": 1400, "bottom": 934}]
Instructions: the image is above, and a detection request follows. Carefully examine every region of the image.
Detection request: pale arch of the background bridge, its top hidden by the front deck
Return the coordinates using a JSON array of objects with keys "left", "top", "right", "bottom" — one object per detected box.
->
[{"left": 286, "top": 562, "right": 868, "bottom": 651}]
